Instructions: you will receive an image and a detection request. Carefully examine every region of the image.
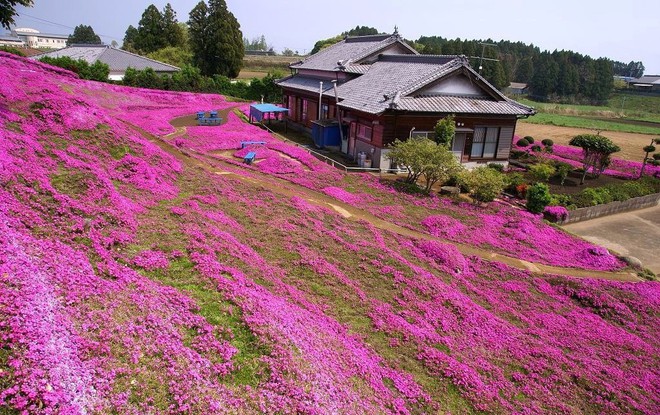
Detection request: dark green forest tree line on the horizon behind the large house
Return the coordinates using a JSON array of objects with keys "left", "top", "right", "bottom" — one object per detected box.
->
[{"left": 312, "top": 26, "right": 644, "bottom": 104}]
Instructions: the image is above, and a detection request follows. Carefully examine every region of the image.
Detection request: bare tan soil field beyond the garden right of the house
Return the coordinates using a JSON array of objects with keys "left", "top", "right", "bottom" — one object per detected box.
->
[{"left": 516, "top": 122, "right": 656, "bottom": 161}]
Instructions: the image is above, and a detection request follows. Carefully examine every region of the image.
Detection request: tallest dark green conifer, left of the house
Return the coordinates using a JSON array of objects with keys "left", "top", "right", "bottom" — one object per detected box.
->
[{"left": 189, "top": 0, "right": 245, "bottom": 78}]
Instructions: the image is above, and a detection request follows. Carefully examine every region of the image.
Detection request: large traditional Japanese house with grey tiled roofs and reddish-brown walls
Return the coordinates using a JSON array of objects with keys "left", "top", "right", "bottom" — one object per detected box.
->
[{"left": 278, "top": 32, "right": 535, "bottom": 169}]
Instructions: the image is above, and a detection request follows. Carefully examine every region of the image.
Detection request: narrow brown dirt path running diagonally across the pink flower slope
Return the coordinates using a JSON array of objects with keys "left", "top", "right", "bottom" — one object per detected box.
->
[{"left": 121, "top": 118, "right": 642, "bottom": 282}]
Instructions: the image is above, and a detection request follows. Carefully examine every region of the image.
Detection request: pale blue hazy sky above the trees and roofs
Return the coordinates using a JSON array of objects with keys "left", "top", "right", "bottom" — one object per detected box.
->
[{"left": 10, "top": 0, "right": 660, "bottom": 74}]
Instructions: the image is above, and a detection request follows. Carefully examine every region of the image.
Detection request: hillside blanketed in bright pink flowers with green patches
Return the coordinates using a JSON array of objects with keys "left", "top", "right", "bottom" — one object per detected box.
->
[{"left": 0, "top": 53, "right": 660, "bottom": 414}]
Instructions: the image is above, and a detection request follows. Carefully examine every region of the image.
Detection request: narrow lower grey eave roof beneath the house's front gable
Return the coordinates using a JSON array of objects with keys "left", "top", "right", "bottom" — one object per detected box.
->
[{"left": 396, "top": 96, "right": 534, "bottom": 115}]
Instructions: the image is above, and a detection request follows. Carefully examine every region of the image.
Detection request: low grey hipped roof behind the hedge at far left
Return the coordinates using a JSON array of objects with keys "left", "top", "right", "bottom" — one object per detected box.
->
[{"left": 33, "top": 45, "right": 179, "bottom": 72}]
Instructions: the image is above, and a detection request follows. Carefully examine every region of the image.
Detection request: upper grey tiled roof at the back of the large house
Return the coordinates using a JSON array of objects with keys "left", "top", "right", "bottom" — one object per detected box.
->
[{"left": 291, "top": 35, "right": 417, "bottom": 71}]
